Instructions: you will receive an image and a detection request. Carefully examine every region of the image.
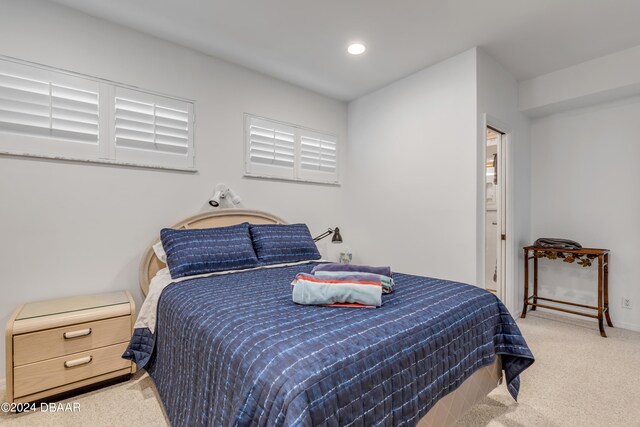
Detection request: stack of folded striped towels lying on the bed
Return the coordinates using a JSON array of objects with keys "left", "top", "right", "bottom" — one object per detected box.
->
[{"left": 291, "top": 263, "right": 394, "bottom": 308}]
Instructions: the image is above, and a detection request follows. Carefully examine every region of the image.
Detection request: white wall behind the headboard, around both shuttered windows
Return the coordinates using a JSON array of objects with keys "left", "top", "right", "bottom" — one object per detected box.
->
[{"left": 0, "top": 0, "right": 349, "bottom": 378}]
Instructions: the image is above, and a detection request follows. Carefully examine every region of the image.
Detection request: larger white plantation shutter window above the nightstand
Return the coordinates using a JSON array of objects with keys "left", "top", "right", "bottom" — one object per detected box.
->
[{"left": 0, "top": 57, "right": 195, "bottom": 170}]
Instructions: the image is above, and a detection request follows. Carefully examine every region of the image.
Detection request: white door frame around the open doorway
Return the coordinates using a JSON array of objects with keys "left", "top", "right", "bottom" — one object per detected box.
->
[{"left": 479, "top": 113, "right": 517, "bottom": 313}]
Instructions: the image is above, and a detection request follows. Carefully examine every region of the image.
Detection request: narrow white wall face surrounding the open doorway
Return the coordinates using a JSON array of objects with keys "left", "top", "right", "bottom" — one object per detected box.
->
[{"left": 477, "top": 49, "right": 531, "bottom": 314}]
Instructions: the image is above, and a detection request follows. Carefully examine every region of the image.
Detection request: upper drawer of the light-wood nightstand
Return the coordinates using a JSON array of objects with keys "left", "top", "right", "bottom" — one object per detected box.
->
[{"left": 13, "top": 316, "right": 131, "bottom": 367}]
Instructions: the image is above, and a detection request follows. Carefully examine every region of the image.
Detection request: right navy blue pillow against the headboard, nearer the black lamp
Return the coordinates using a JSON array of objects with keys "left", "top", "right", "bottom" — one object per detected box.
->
[{"left": 250, "top": 224, "right": 320, "bottom": 265}]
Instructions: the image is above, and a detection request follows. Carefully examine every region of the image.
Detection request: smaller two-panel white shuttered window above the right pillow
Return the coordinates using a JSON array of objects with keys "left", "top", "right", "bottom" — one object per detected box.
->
[{"left": 245, "top": 114, "right": 338, "bottom": 184}]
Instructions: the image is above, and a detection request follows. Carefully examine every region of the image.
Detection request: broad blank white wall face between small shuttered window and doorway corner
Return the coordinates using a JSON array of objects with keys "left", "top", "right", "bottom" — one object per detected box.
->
[{"left": 345, "top": 49, "right": 477, "bottom": 283}]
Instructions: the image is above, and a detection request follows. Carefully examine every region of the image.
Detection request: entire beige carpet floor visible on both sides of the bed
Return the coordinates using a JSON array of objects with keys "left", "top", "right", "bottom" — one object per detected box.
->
[{"left": 0, "top": 312, "right": 640, "bottom": 427}]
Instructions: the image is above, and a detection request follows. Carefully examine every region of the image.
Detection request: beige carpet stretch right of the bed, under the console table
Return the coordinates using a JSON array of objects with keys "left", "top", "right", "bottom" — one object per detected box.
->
[{"left": 456, "top": 312, "right": 640, "bottom": 427}]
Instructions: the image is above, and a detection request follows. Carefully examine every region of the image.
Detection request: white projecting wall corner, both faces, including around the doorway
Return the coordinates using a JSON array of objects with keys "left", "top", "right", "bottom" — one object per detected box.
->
[{"left": 344, "top": 49, "right": 531, "bottom": 312}]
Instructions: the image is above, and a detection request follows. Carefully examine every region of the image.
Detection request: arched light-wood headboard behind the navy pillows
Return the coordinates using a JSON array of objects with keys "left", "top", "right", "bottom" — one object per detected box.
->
[{"left": 140, "top": 209, "right": 286, "bottom": 296}]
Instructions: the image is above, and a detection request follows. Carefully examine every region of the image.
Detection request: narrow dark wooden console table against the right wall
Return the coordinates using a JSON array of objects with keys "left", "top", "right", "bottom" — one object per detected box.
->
[{"left": 520, "top": 246, "right": 613, "bottom": 337}]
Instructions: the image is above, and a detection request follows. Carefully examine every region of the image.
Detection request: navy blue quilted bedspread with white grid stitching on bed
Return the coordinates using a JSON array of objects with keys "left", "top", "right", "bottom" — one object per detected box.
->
[{"left": 125, "top": 263, "right": 533, "bottom": 426}]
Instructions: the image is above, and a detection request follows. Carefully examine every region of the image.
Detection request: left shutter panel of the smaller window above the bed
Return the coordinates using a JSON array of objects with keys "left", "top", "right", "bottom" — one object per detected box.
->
[{"left": 245, "top": 115, "right": 296, "bottom": 179}]
